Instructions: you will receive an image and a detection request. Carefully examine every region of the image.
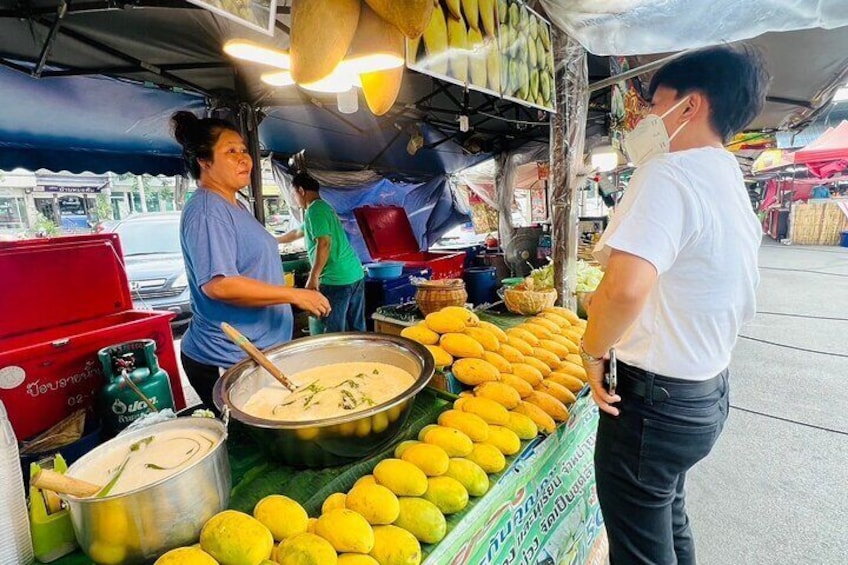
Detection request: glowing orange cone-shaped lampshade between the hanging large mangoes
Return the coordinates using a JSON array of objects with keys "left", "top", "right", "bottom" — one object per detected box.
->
[{"left": 339, "top": 4, "right": 406, "bottom": 74}]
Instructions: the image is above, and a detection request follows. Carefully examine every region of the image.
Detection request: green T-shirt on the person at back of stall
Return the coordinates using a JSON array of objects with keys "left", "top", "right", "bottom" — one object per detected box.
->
[{"left": 303, "top": 199, "right": 365, "bottom": 285}]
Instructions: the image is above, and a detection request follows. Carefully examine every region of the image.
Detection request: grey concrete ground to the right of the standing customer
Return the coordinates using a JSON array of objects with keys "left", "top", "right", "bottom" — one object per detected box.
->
[{"left": 687, "top": 238, "right": 848, "bottom": 565}]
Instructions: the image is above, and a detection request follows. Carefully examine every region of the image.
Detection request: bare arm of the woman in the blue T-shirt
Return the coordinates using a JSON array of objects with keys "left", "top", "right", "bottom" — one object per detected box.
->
[{"left": 202, "top": 276, "right": 330, "bottom": 317}]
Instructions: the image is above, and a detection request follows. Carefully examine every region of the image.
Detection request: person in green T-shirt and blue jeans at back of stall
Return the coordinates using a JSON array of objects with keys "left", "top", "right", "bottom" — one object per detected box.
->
[{"left": 277, "top": 173, "right": 365, "bottom": 333}]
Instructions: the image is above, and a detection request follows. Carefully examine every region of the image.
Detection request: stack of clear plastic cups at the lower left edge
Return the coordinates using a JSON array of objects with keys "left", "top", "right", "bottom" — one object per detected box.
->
[{"left": 0, "top": 401, "right": 35, "bottom": 565}]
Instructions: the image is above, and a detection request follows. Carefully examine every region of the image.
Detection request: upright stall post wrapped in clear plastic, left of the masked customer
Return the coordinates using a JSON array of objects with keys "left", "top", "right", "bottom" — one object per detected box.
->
[{"left": 550, "top": 30, "right": 589, "bottom": 308}]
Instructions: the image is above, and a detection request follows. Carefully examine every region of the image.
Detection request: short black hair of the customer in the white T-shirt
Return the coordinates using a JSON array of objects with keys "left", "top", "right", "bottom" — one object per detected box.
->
[{"left": 648, "top": 45, "right": 771, "bottom": 143}]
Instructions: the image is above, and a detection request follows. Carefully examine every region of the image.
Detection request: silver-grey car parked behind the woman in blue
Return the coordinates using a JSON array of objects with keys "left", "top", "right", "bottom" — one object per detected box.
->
[{"left": 110, "top": 212, "right": 191, "bottom": 326}]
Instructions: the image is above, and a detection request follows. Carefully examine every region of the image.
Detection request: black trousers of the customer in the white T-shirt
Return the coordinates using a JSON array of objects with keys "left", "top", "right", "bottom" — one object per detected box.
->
[{"left": 595, "top": 362, "right": 730, "bottom": 565}]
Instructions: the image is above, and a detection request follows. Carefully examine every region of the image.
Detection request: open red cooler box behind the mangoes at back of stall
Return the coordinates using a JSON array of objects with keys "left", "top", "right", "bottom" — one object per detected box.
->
[{"left": 353, "top": 206, "right": 465, "bottom": 279}]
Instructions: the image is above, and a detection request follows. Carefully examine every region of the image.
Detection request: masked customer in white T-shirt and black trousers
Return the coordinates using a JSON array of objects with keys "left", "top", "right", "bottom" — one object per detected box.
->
[{"left": 581, "top": 46, "right": 769, "bottom": 565}]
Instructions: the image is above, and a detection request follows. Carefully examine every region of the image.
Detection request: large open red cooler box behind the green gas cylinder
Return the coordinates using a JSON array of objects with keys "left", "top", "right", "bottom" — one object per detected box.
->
[{"left": 0, "top": 234, "right": 185, "bottom": 440}]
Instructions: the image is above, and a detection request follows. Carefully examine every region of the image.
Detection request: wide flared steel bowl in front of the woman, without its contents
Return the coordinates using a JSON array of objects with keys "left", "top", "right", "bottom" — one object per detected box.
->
[{"left": 213, "top": 333, "right": 434, "bottom": 467}]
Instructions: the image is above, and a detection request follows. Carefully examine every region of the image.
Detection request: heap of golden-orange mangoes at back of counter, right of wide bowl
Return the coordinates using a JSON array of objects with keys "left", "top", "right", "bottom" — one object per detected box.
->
[{"left": 401, "top": 306, "right": 587, "bottom": 433}]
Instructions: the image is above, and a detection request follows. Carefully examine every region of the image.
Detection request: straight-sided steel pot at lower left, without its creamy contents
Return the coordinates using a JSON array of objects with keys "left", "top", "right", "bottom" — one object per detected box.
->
[{"left": 63, "top": 418, "right": 231, "bottom": 565}]
